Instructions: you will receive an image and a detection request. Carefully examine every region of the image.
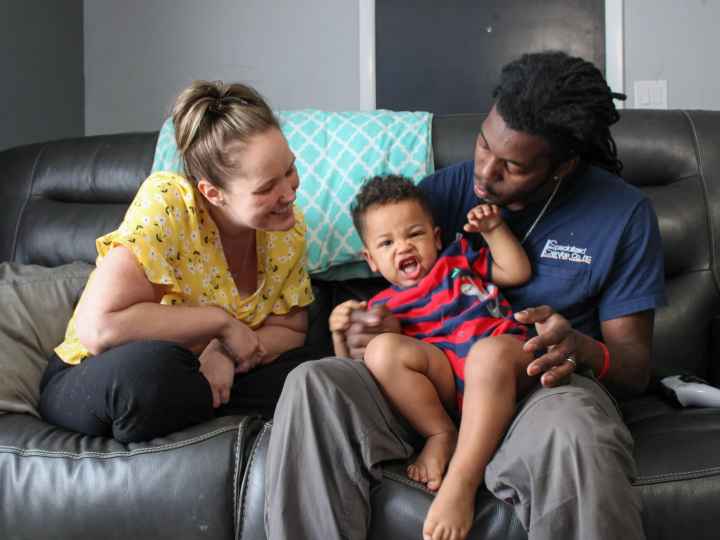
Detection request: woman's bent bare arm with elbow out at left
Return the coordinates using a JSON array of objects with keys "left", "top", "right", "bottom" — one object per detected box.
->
[{"left": 75, "top": 246, "right": 239, "bottom": 354}]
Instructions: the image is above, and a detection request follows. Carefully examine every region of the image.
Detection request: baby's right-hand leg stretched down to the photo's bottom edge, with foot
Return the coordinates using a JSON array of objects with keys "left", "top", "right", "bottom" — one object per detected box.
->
[{"left": 423, "top": 335, "right": 533, "bottom": 540}]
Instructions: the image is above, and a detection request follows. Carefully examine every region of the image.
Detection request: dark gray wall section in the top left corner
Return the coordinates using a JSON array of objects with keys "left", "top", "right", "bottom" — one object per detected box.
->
[{"left": 0, "top": 0, "right": 84, "bottom": 149}]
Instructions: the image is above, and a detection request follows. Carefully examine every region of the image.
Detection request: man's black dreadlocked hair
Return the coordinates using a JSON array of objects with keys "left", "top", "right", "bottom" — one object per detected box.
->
[{"left": 493, "top": 51, "right": 625, "bottom": 174}]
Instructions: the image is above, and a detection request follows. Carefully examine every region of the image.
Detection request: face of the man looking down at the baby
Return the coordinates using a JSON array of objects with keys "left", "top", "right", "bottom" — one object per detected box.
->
[{"left": 475, "top": 106, "right": 553, "bottom": 210}]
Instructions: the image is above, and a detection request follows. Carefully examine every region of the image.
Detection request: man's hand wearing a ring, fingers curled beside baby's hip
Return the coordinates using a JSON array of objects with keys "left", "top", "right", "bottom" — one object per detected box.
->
[{"left": 515, "top": 306, "right": 579, "bottom": 386}]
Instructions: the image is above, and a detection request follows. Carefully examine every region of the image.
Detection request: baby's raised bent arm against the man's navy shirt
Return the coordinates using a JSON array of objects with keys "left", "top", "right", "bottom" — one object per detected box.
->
[{"left": 465, "top": 204, "right": 532, "bottom": 287}]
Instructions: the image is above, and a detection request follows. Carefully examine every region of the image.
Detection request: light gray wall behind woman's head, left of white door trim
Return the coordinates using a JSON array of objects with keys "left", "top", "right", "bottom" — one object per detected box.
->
[{"left": 85, "top": 0, "right": 360, "bottom": 135}]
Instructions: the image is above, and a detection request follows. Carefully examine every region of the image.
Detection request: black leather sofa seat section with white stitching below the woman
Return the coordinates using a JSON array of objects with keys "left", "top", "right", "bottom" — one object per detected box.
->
[{"left": 0, "top": 414, "right": 262, "bottom": 539}]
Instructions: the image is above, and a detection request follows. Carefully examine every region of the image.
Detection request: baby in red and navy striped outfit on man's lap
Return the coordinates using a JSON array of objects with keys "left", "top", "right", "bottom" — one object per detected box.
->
[{"left": 330, "top": 176, "right": 535, "bottom": 540}]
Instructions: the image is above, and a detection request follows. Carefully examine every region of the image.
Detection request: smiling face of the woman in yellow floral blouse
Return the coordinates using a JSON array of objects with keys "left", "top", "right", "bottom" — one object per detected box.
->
[{"left": 215, "top": 128, "right": 300, "bottom": 233}]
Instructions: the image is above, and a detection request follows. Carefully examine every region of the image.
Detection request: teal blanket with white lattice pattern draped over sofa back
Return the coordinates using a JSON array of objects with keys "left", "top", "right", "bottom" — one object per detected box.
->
[{"left": 152, "top": 109, "right": 433, "bottom": 279}]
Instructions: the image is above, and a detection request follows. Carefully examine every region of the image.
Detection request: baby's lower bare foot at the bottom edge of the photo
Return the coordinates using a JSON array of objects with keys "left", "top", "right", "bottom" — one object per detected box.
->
[{"left": 423, "top": 474, "right": 477, "bottom": 540}]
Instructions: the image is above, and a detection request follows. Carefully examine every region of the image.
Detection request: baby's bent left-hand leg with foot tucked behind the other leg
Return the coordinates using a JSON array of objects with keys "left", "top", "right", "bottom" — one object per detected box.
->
[{"left": 365, "top": 334, "right": 457, "bottom": 491}]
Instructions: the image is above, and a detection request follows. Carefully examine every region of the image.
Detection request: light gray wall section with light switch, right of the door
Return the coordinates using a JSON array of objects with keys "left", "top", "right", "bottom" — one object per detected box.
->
[{"left": 624, "top": 0, "right": 720, "bottom": 110}]
